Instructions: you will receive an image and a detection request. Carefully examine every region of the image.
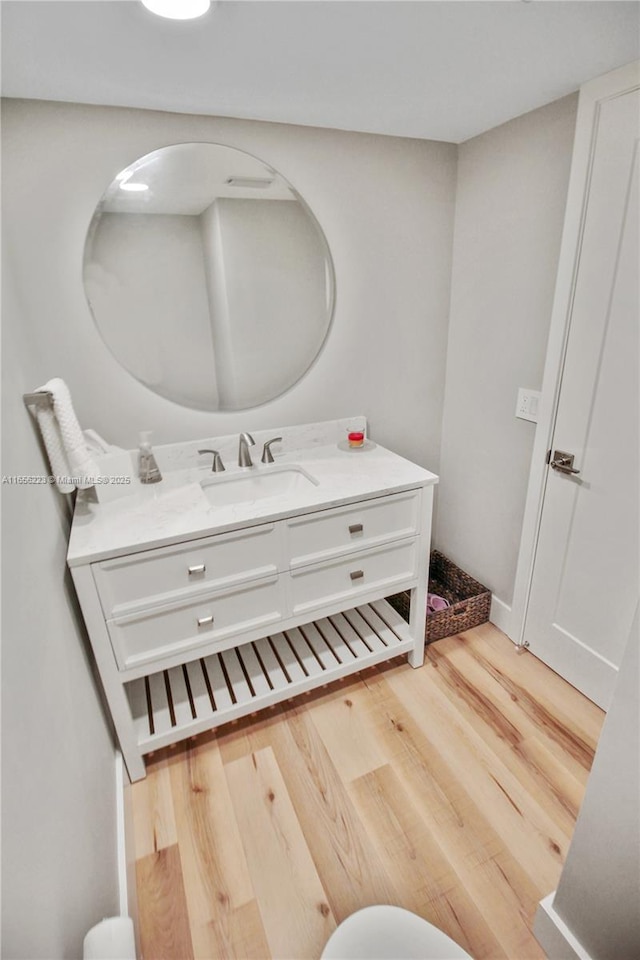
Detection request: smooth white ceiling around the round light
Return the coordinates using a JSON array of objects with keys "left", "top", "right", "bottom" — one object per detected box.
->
[{"left": 0, "top": 0, "right": 640, "bottom": 143}]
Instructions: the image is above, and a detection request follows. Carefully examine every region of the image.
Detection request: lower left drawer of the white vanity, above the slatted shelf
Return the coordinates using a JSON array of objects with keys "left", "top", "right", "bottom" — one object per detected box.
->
[{"left": 107, "top": 577, "right": 286, "bottom": 670}]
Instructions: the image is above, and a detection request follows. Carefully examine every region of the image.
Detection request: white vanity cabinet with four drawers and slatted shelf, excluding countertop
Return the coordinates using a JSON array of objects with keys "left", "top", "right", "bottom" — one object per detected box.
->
[{"left": 71, "top": 468, "right": 432, "bottom": 780}]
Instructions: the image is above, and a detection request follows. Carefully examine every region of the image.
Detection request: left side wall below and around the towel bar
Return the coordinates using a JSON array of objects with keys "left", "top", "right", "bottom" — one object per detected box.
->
[{"left": 2, "top": 251, "right": 119, "bottom": 960}]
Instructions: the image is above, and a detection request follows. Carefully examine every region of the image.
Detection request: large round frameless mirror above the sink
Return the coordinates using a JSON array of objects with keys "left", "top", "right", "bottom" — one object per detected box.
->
[{"left": 84, "top": 143, "right": 335, "bottom": 410}]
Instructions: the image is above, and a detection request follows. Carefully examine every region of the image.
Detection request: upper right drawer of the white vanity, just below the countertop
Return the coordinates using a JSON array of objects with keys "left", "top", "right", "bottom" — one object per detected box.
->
[{"left": 285, "top": 490, "right": 421, "bottom": 569}]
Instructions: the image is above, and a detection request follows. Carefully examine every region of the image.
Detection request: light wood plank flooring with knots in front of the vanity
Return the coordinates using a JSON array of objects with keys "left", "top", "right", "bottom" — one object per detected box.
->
[{"left": 133, "top": 624, "right": 604, "bottom": 960}]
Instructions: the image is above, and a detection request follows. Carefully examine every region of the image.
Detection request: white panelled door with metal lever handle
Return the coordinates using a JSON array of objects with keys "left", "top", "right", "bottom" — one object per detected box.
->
[{"left": 524, "top": 71, "right": 640, "bottom": 709}]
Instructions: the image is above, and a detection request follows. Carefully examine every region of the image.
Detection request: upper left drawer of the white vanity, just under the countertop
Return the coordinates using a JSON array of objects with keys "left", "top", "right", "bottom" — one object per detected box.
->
[{"left": 92, "top": 523, "right": 280, "bottom": 618}]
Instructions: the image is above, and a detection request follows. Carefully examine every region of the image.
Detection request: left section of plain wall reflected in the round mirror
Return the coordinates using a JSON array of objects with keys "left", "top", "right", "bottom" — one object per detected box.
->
[{"left": 85, "top": 213, "right": 217, "bottom": 409}]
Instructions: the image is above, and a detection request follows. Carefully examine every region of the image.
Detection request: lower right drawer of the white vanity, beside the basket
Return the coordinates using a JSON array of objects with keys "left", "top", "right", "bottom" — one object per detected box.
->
[{"left": 289, "top": 538, "right": 419, "bottom": 616}]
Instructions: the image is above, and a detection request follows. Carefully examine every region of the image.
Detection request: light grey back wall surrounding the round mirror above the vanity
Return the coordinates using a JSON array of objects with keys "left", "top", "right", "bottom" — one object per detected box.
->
[{"left": 3, "top": 100, "right": 456, "bottom": 471}]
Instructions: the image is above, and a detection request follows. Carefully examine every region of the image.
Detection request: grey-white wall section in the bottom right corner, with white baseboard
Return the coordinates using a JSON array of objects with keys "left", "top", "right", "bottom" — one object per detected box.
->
[{"left": 535, "top": 613, "right": 640, "bottom": 960}]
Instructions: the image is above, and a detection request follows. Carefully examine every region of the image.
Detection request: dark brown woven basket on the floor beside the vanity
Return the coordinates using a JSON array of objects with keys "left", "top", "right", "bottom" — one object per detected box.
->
[{"left": 387, "top": 550, "right": 491, "bottom": 643}]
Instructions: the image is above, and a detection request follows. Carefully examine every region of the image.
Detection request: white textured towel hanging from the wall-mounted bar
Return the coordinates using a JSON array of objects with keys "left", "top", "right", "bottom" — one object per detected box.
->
[{"left": 36, "top": 377, "right": 99, "bottom": 493}]
